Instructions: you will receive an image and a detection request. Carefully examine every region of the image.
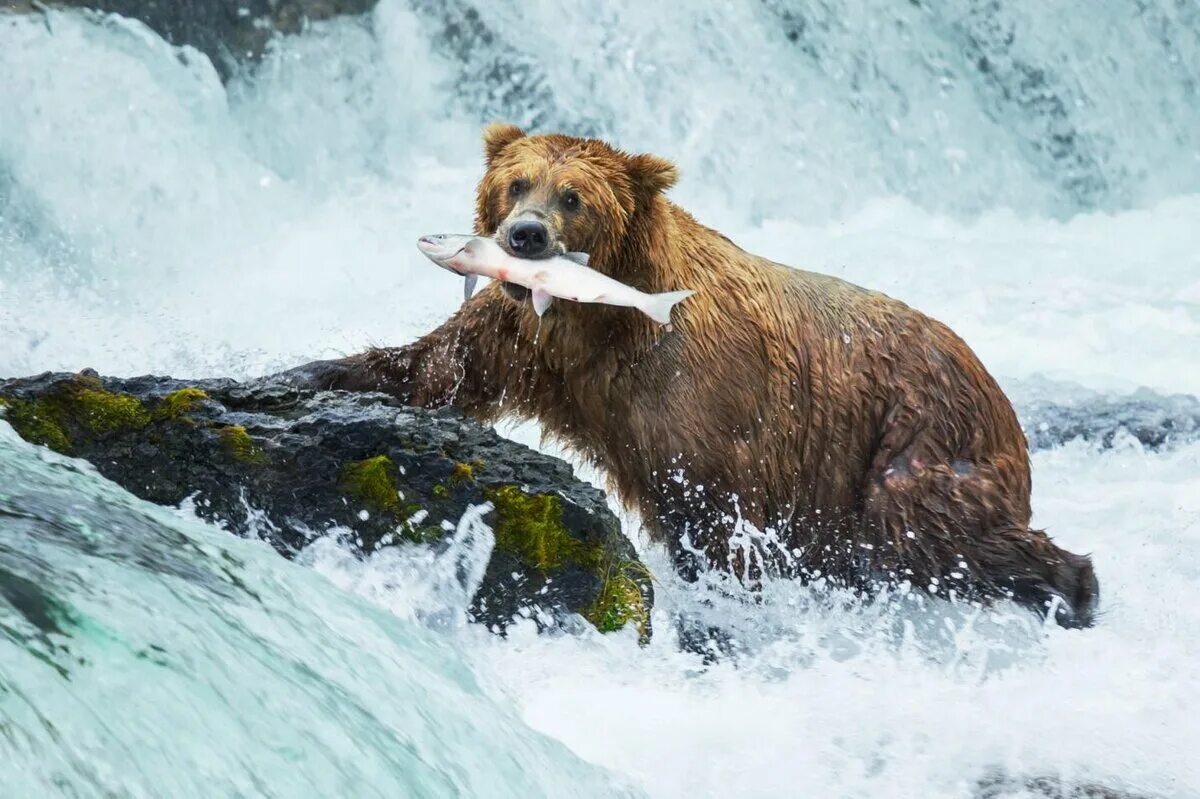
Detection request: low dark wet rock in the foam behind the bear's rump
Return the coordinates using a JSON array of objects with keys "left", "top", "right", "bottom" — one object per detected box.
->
[{"left": 1018, "top": 389, "right": 1200, "bottom": 450}]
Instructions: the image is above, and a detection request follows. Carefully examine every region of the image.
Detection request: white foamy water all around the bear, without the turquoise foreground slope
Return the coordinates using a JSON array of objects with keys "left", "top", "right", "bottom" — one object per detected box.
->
[{"left": 0, "top": 2, "right": 1200, "bottom": 797}]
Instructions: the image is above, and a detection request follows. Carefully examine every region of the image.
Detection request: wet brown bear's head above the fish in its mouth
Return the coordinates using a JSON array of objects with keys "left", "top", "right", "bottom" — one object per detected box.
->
[{"left": 475, "top": 124, "right": 678, "bottom": 277}]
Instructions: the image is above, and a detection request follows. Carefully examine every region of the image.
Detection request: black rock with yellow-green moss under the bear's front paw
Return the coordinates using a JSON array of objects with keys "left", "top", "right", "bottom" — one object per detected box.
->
[{"left": 0, "top": 371, "right": 653, "bottom": 639}]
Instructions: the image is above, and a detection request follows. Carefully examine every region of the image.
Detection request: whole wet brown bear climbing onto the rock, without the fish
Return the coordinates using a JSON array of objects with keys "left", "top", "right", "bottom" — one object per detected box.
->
[{"left": 286, "top": 125, "right": 1098, "bottom": 626}]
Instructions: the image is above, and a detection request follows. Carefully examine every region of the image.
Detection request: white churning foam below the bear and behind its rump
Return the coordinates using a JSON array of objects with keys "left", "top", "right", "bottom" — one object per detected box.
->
[{"left": 314, "top": 441, "right": 1200, "bottom": 797}]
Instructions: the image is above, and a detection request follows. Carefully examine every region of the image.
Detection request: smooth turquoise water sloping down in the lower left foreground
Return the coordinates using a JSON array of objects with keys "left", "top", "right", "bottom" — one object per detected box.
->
[{"left": 0, "top": 425, "right": 635, "bottom": 797}]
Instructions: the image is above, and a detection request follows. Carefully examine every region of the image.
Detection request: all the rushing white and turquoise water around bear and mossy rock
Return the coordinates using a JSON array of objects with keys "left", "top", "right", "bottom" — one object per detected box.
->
[{"left": 0, "top": 0, "right": 1200, "bottom": 797}]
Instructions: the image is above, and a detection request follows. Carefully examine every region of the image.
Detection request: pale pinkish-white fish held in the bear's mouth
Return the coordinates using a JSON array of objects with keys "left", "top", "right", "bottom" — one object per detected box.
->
[{"left": 416, "top": 234, "right": 695, "bottom": 325}]
